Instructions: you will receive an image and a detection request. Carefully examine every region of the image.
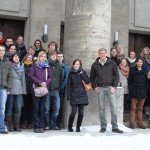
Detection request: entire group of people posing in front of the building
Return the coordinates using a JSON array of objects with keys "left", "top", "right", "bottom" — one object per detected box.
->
[{"left": 0, "top": 32, "right": 150, "bottom": 134}]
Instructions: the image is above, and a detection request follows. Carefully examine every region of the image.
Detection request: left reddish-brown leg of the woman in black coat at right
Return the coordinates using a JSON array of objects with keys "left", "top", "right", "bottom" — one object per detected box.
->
[{"left": 130, "top": 99, "right": 136, "bottom": 129}]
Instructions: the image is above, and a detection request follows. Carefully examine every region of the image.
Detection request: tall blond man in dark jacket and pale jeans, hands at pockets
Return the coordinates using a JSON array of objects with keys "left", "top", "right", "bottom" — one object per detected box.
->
[{"left": 90, "top": 48, "right": 123, "bottom": 133}]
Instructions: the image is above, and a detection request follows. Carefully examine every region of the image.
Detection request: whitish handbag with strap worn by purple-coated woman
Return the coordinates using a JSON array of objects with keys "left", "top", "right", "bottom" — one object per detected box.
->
[{"left": 33, "top": 68, "right": 48, "bottom": 97}]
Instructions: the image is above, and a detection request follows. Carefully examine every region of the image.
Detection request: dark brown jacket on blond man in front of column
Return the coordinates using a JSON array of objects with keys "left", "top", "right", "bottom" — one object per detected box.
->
[{"left": 90, "top": 57, "right": 119, "bottom": 89}]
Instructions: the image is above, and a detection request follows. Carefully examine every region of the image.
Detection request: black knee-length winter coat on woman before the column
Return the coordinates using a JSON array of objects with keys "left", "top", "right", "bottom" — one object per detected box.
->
[{"left": 67, "top": 68, "right": 90, "bottom": 105}]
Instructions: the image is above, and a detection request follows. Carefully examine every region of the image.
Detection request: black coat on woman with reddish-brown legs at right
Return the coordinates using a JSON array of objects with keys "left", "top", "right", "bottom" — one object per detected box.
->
[{"left": 128, "top": 67, "right": 148, "bottom": 100}]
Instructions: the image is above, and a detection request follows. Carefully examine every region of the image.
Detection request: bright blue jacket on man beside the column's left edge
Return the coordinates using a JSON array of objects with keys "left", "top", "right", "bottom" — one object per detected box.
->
[{"left": 60, "top": 62, "right": 69, "bottom": 93}]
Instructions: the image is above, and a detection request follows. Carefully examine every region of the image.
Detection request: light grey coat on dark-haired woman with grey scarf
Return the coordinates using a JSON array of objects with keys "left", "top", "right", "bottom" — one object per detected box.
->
[{"left": 10, "top": 63, "right": 26, "bottom": 95}]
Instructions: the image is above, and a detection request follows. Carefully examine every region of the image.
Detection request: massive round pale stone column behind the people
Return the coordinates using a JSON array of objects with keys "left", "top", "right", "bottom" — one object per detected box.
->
[{"left": 64, "top": 0, "right": 122, "bottom": 129}]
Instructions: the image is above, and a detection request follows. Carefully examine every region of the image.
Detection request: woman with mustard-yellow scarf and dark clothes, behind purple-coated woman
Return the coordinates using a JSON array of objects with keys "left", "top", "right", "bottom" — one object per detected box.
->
[{"left": 21, "top": 54, "right": 34, "bottom": 129}]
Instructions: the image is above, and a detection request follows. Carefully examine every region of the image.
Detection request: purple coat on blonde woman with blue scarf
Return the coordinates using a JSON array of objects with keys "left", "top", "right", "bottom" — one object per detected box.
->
[{"left": 30, "top": 63, "right": 52, "bottom": 86}]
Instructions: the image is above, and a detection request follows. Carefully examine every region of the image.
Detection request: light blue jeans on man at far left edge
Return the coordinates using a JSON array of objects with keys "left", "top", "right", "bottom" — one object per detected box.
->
[{"left": 0, "top": 89, "right": 7, "bottom": 132}]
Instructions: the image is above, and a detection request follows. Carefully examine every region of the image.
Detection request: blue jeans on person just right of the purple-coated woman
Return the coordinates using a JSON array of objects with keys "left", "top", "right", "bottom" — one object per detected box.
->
[{"left": 45, "top": 90, "right": 60, "bottom": 128}]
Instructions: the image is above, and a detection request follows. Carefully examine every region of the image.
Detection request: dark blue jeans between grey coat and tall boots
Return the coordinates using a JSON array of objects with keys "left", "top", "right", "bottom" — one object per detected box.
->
[{"left": 6, "top": 94, "right": 23, "bottom": 115}]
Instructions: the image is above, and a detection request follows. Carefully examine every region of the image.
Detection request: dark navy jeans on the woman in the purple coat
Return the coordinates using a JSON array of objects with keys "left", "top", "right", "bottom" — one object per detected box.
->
[{"left": 32, "top": 93, "right": 47, "bottom": 129}]
